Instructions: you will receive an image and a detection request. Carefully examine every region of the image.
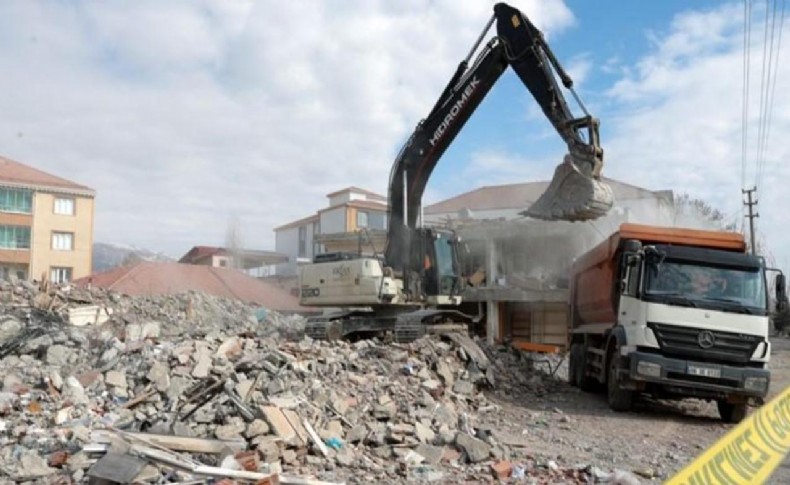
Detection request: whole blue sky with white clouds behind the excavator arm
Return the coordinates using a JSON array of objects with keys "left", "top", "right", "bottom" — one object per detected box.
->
[{"left": 0, "top": 0, "right": 790, "bottom": 269}]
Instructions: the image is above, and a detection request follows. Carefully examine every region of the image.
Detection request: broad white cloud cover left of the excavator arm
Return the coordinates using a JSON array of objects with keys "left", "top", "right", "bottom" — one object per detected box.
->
[{"left": 0, "top": 0, "right": 573, "bottom": 256}]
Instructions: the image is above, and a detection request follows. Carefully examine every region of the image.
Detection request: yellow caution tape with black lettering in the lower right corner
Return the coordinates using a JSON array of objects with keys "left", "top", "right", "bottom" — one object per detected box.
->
[{"left": 665, "top": 387, "right": 790, "bottom": 485}]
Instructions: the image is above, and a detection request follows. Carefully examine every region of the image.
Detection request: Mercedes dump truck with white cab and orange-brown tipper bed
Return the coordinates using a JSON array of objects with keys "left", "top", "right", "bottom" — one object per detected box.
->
[{"left": 569, "top": 224, "right": 785, "bottom": 422}]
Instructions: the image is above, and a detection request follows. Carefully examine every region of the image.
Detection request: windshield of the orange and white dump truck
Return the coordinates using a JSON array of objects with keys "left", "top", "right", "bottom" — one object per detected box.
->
[{"left": 645, "top": 261, "right": 766, "bottom": 312}]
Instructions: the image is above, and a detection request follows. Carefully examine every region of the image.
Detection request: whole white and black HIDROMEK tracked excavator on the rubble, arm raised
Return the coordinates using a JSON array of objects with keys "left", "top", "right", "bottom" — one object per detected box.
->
[{"left": 299, "top": 3, "right": 613, "bottom": 342}]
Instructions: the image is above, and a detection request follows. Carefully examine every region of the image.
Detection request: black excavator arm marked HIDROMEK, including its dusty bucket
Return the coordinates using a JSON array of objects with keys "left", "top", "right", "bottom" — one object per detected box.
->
[{"left": 385, "top": 3, "right": 613, "bottom": 270}]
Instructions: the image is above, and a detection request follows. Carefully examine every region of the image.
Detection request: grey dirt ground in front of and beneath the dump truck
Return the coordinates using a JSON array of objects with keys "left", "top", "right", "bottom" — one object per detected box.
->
[{"left": 476, "top": 339, "right": 790, "bottom": 483}]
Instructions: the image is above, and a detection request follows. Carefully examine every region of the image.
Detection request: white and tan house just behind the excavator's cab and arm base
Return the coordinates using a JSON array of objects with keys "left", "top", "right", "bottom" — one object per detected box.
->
[{"left": 274, "top": 187, "right": 387, "bottom": 276}]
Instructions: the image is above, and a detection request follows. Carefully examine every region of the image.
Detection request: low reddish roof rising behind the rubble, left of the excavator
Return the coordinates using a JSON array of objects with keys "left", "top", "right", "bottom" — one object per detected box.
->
[{"left": 74, "top": 261, "right": 312, "bottom": 312}]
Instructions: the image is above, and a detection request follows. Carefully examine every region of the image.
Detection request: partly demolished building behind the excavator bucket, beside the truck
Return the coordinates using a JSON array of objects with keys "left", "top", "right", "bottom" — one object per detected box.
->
[{"left": 423, "top": 179, "right": 679, "bottom": 348}]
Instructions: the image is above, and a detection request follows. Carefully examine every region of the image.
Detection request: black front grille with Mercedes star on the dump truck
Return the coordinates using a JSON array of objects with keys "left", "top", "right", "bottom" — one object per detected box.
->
[{"left": 647, "top": 323, "right": 763, "bottom": 364}]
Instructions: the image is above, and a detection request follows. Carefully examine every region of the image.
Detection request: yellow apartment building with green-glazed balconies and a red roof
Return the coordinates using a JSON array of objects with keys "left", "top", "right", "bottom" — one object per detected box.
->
[{"left": 0, "top": 157, "right": 96, "bottom": 283}]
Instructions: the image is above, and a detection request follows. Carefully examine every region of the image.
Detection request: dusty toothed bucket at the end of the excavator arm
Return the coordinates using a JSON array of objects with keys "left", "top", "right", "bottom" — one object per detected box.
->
[{"left": 521, "top": 155, "right": 614, "bottom": 221}]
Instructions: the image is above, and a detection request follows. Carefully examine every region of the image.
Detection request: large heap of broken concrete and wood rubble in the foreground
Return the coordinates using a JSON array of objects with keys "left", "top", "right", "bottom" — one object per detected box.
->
[{"left": 0, "top": 283, "right": 636, "bottom": 484}]
